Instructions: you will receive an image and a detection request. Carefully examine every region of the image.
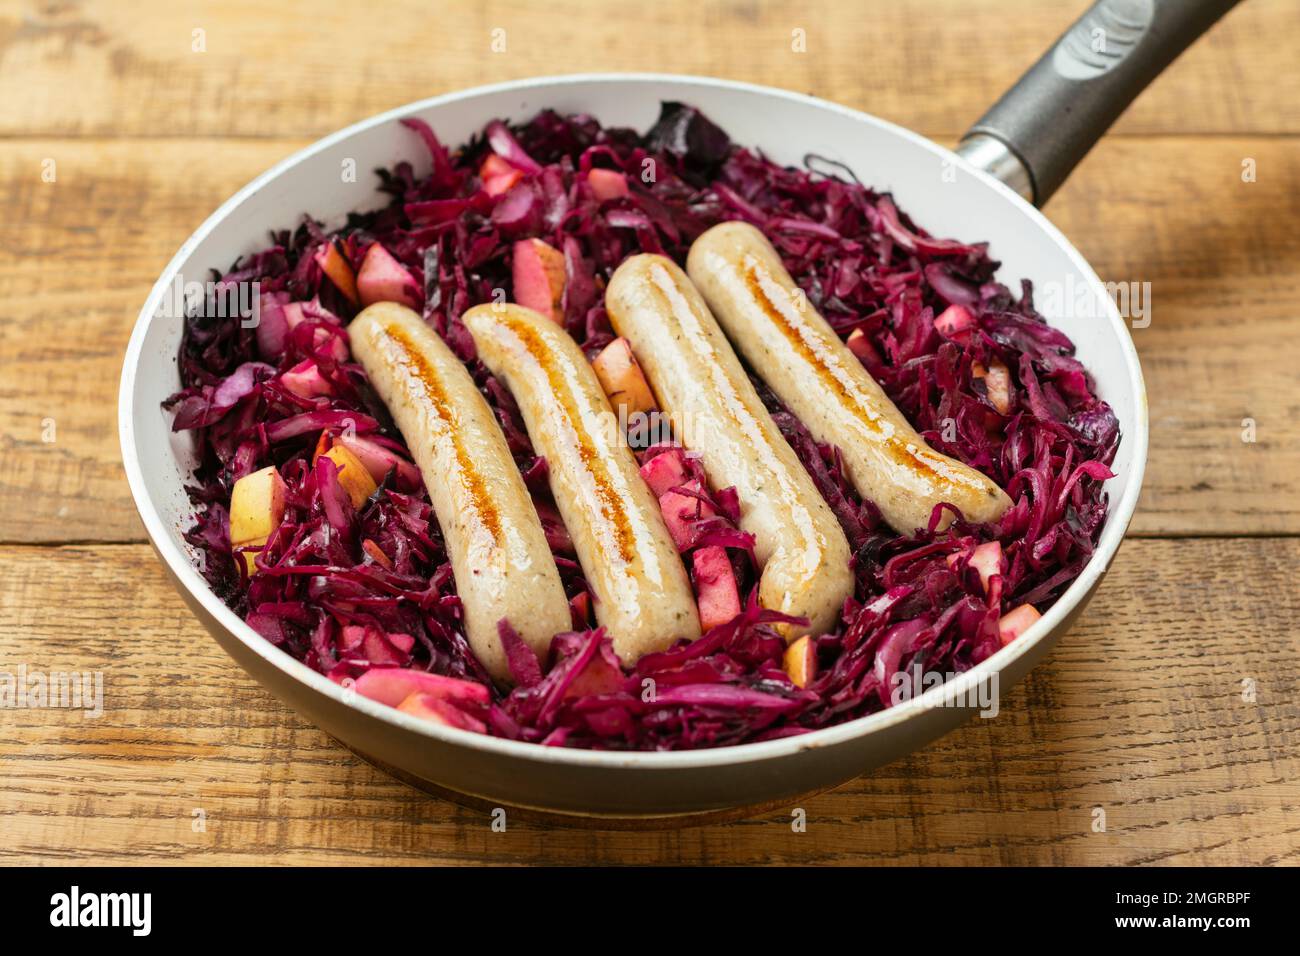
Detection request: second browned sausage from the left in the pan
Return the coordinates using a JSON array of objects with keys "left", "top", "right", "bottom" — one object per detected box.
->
[{"left": 463, "top": 303, "right": 699, "bottom": 665}]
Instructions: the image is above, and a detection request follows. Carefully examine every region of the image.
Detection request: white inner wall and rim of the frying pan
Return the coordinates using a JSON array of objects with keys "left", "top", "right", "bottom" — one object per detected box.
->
[{"left": 121, "top": 74, "right": 1147, "bottom": 765}]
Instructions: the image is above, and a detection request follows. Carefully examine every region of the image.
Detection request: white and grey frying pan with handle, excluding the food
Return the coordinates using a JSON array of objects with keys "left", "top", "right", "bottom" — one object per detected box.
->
[{"left": 118, "top": 0, "right": 1235, "bottom": 825}]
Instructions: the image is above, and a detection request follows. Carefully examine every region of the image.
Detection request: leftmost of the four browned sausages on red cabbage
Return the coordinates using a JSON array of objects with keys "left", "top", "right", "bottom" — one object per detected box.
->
[{"left": 348, "top": 302, "right": 572, "bottom": 682}]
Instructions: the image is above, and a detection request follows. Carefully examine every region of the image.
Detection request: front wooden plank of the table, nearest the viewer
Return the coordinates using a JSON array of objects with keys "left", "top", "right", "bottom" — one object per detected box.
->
[{"left": 0, "top": 540, "right": 1300, "bottom": 865}]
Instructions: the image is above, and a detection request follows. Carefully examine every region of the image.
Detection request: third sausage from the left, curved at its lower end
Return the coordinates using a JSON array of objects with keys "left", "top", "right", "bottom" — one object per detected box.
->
[{"left": 605, "top": 255, "right": 853, "bottom": 640}]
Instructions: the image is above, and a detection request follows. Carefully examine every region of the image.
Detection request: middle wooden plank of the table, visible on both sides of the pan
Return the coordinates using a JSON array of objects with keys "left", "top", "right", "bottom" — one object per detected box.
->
[{"left": 0, "top": 137, "right": 1300, "bottom": 542}]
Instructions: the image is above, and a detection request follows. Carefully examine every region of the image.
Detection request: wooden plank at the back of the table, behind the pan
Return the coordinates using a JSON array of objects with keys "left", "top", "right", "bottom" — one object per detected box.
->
[{"left": 0, "top": 0, "right": 1300, "bottom": 138}]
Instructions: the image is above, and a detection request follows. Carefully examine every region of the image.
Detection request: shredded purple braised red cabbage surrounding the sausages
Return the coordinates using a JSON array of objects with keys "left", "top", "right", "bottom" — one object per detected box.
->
[{"left": 168, "top": 103, "right": 1119, "bottom": 749}]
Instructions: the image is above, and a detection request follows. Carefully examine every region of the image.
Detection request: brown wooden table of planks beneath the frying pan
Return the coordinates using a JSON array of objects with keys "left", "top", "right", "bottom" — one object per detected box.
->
[{"left": 0, "top": 0, "right": 1300, "bottom": 864}]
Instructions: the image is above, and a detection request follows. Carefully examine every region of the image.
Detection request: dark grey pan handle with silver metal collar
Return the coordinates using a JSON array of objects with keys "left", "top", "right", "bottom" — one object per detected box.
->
[{"left": 957, "top": 0, "right": 1239, "bottom": 206}]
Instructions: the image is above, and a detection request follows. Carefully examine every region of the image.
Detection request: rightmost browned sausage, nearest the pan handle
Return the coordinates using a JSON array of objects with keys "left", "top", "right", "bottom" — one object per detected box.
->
[{"left": 686, "top": 222, "right": 1011, "bottom": 535}]
